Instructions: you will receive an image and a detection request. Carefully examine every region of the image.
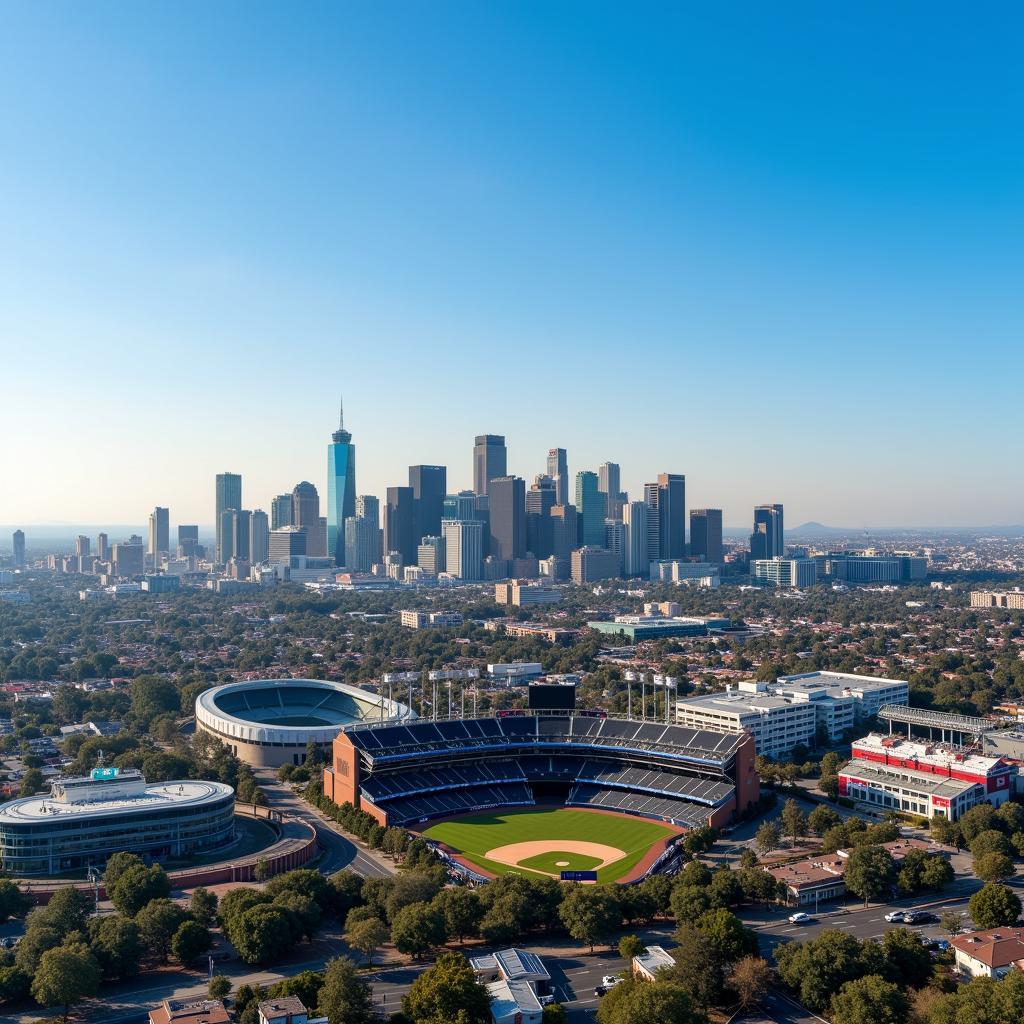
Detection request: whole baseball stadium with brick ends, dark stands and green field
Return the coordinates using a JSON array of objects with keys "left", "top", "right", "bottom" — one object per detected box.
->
[{"left": 324, "top": 711, "right": 759, "bottom": 883}]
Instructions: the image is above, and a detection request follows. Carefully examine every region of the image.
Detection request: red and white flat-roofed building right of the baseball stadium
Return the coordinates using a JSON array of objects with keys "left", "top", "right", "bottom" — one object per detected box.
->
[{"left": 839, "top": 733, "right": 1017, "bottom": 821}]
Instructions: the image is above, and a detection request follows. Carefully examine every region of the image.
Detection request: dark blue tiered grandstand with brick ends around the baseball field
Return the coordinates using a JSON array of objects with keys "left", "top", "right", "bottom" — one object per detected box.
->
[{"left": 324, "top": 711, "right": 759, "bottom": 827}]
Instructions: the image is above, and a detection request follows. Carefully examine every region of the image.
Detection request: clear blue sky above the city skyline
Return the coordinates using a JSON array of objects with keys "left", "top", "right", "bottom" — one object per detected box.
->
[{"left": 0, "top": 2, "right": 1024, "bottom": 526}]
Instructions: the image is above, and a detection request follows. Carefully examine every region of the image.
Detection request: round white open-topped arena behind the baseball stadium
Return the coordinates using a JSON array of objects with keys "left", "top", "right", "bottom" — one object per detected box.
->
[{"left": 196, "top": 679, "right": 415, "bottom": 768}]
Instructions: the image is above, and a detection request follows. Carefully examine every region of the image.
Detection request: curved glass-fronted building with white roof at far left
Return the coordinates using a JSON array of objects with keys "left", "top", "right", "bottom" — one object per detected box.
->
[{"left": 0, "top": 768, "right": 234, "bottom": 876}]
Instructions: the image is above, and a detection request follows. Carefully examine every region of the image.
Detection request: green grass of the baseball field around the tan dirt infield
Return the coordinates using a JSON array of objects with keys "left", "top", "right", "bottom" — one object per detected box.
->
[{"left": 424, "top": 807, "right": 673, "bottom": 882}]
